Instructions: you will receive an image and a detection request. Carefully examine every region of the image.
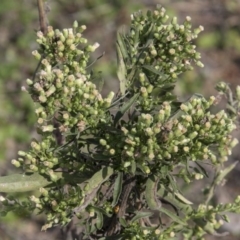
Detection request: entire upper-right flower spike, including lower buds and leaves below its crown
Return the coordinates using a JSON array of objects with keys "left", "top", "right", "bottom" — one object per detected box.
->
[{"left": 124, "top": 6, "right": 203, "bottom": 110}]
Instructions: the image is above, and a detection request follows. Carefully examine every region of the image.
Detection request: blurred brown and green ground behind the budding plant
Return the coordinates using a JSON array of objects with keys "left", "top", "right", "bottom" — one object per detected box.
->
[{"left": 0, "top": 0, "right": 240, "bottom": 240}]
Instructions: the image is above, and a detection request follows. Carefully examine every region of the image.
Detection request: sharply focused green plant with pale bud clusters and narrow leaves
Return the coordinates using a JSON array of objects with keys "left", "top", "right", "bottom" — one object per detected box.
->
[{"left": 0, "top": 3, "right": 240, "bottom": 239}]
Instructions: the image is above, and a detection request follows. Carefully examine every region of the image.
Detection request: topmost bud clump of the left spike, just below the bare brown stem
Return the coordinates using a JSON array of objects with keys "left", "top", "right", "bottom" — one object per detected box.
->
[{"left": 33, "top": 21, "right": 91, "bottom": 73}]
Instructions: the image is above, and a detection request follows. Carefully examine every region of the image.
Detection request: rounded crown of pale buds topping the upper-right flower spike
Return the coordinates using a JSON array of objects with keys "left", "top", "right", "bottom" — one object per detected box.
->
[{"left": 129, "top": 6, "right": 203, "bottom": 72}]
